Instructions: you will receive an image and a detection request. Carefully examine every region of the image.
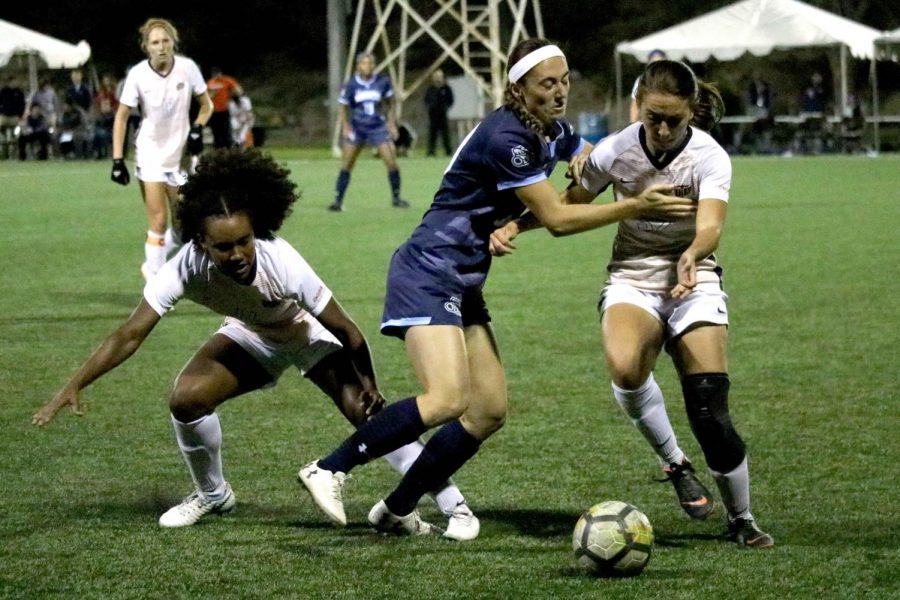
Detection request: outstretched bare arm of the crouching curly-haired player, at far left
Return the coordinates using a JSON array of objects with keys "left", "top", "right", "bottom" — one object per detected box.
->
[{"left": 31, "top": 300, "right": 160, "bottom": 426}]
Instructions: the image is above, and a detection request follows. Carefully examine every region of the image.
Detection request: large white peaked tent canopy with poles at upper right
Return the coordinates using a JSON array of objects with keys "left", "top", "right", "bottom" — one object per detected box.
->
[{"left": 616, "top": 0, "right": 882, "bottom": 126}]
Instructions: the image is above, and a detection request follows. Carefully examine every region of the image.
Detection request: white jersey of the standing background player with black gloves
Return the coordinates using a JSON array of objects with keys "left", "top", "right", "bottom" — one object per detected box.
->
[{"left": 119, "top": 55, "right": 206, "bottom": 172}]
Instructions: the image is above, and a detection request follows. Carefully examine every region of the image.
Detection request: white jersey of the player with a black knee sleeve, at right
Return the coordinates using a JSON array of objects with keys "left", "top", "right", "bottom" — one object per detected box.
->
[{"left": 581, "top": 123, "right": 731, "bottom": 292}]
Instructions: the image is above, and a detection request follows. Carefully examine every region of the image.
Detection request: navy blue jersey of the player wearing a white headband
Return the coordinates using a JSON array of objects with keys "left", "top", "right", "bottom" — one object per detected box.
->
[{"left": 398, "top": 107, "right": 584, "bottom": 287}]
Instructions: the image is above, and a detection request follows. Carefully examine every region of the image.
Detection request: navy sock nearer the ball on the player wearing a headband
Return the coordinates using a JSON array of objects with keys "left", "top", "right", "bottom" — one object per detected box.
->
[{"left": 384, "top": 419, "right": 481, "bottom": 516}]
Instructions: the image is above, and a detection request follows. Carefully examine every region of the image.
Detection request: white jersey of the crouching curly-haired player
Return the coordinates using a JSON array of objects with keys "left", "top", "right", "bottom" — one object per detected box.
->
[{"left": 144, "top": 238, "right": 331, "bottom": 341}]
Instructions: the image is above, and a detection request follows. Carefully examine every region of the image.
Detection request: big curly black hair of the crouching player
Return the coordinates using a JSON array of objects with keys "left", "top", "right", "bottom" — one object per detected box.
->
[{"left": 174, "top": 148, "right": 300, "bottom": 243}]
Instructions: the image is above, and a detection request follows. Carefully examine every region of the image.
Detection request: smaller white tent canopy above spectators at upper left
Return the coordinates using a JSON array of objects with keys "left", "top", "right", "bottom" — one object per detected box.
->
[{"left": 0, "top": 19, "right": 91, "bottom": 90}]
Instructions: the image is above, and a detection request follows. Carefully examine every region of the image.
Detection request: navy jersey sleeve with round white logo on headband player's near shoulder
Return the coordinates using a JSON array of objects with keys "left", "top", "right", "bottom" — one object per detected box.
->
[{"left": 484, "top": 131, "right": 547, "bottom": 190}]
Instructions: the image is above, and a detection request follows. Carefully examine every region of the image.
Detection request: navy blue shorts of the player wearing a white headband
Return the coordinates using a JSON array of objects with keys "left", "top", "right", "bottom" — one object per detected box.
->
[{"left": 381, "top": 251, "right": 491, "bottom": 339}]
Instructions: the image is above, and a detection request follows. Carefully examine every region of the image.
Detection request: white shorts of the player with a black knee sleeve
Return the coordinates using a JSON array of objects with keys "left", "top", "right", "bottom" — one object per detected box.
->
[{"left": 600, "top": 283, "right": 728, "bottom": 339}]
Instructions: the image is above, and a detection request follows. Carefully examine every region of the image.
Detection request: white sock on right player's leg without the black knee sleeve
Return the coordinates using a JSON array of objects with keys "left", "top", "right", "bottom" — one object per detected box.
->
[{"left": 612, "top": 373, "right": 684, "bottom": 466}]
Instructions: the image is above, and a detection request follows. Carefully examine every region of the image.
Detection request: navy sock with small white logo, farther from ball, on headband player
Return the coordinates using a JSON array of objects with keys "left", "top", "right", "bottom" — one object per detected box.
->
[{"left": 319, "top": 397, "right": 426, "bottom": 479}]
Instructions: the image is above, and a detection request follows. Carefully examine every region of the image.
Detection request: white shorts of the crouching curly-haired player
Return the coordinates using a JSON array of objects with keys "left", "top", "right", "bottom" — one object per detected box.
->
[{"left": 217, "top": 314, "right": 342, "bottom": 384}]
